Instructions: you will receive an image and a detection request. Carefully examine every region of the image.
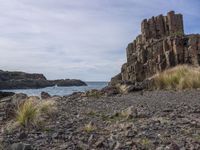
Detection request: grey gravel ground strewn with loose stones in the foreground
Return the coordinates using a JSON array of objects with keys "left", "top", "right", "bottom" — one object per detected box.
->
[{"left": 0, "top": 90, "right": 200, "bottom": 150}]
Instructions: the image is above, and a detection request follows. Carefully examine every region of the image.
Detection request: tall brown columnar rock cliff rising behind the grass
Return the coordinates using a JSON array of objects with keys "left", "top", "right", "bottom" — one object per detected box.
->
[{"left": 111, "top": 11, "right": 200, "bottom": 85}]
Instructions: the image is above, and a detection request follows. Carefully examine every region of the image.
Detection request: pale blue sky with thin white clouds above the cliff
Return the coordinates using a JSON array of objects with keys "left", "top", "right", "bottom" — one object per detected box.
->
[{"left": 0, "top": 0, "right": 200, "bottom": 81}]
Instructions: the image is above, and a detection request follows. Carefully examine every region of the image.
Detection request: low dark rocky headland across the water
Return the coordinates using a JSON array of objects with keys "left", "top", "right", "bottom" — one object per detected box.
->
[{"left": 0, "top": 70, "right": 87, "bottom": 89}]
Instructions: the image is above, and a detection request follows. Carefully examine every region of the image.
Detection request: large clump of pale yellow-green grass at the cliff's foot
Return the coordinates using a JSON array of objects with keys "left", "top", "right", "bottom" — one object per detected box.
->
[{"left": 153, "top": 65, "right": 200, "bottom": 90}]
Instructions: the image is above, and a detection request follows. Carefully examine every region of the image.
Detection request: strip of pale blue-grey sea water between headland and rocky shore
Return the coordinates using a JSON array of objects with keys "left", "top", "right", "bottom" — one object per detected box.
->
[{"left": 2, "top": 82, "right": 108, "bottom": 96}]
